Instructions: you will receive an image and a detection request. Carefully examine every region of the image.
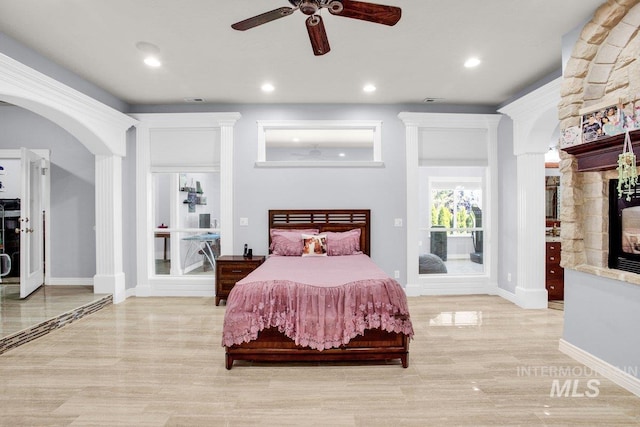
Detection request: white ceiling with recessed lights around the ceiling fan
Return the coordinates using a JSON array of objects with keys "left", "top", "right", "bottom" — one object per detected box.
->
[{"left": 0, "top": 0, "right": 604, "bottom": 105}]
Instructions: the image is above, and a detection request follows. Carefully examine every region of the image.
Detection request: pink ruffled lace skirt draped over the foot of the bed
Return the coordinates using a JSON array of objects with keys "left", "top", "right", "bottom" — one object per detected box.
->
[{"left": 222, "top": 270, "right": 413, "bottom": 350}]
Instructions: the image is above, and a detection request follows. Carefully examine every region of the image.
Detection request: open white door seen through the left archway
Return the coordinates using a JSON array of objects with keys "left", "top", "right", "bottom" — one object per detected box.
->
[{"left": 20, "top": 148, "right": 49, "bottom": 298}]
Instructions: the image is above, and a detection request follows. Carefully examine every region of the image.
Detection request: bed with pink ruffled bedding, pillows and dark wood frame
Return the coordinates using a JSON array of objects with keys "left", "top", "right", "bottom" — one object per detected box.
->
[{"left": 222, "top": 210, "right": 413, "bottom": 369}]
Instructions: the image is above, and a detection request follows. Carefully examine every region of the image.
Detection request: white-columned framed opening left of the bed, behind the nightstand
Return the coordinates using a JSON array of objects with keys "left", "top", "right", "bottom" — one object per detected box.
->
[{"left": 134, "top": 113, "right": 240, "bottom": 296}]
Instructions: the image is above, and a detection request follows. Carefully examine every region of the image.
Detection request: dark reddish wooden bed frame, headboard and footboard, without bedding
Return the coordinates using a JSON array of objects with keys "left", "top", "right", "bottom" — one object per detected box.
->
[{"left": 225, "top": 209, "right": 409, "bottom": 369}]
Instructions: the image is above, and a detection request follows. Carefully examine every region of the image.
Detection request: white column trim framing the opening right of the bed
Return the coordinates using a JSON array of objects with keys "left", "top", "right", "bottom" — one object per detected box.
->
[{"left": 398, "top": 112, "right": 502, "bottom": 295}]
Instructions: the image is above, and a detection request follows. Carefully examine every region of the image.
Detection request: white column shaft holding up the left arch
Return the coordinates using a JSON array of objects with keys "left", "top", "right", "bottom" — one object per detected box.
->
[{"left": 93, "top": 155, "right": 125, "bottom": 303}]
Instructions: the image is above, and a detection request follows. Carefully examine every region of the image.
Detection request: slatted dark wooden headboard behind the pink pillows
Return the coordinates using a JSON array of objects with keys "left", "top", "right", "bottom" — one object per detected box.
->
[{"left": 269, "top": 209, "right": 371, "bottom": 256}]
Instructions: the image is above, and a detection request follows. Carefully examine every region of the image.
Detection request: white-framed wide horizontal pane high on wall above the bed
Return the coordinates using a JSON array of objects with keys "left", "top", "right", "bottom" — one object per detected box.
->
[{"left": 257, "top": 120, "right": 382, "bottom": 166}]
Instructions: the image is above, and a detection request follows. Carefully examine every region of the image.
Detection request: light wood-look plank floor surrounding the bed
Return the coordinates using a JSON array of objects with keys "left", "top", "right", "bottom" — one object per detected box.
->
[{"left": 0, "top": 296, "right": 640, "bottom": 427}]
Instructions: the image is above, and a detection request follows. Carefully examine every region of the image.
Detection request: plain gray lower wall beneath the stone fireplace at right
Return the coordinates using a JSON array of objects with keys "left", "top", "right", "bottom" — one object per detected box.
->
[{"left": 563, "top": 270, "right": 640, "bottom": 378}]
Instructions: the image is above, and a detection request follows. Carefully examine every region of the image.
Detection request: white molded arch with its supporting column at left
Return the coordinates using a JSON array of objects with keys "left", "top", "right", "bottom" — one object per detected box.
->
[{"left": 0, "top": 54, "right": 137, "bottom": 303}]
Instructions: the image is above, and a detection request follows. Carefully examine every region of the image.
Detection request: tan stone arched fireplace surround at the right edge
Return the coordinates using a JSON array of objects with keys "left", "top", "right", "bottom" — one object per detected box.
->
[{"left": 558, "top": 0, "right": 640, "bottom": 285}]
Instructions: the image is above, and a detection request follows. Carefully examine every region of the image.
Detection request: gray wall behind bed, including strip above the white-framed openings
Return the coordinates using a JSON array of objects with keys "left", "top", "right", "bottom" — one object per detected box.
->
[{"left": 133, "top": 104, "right": 495, "bottom": 283}]
